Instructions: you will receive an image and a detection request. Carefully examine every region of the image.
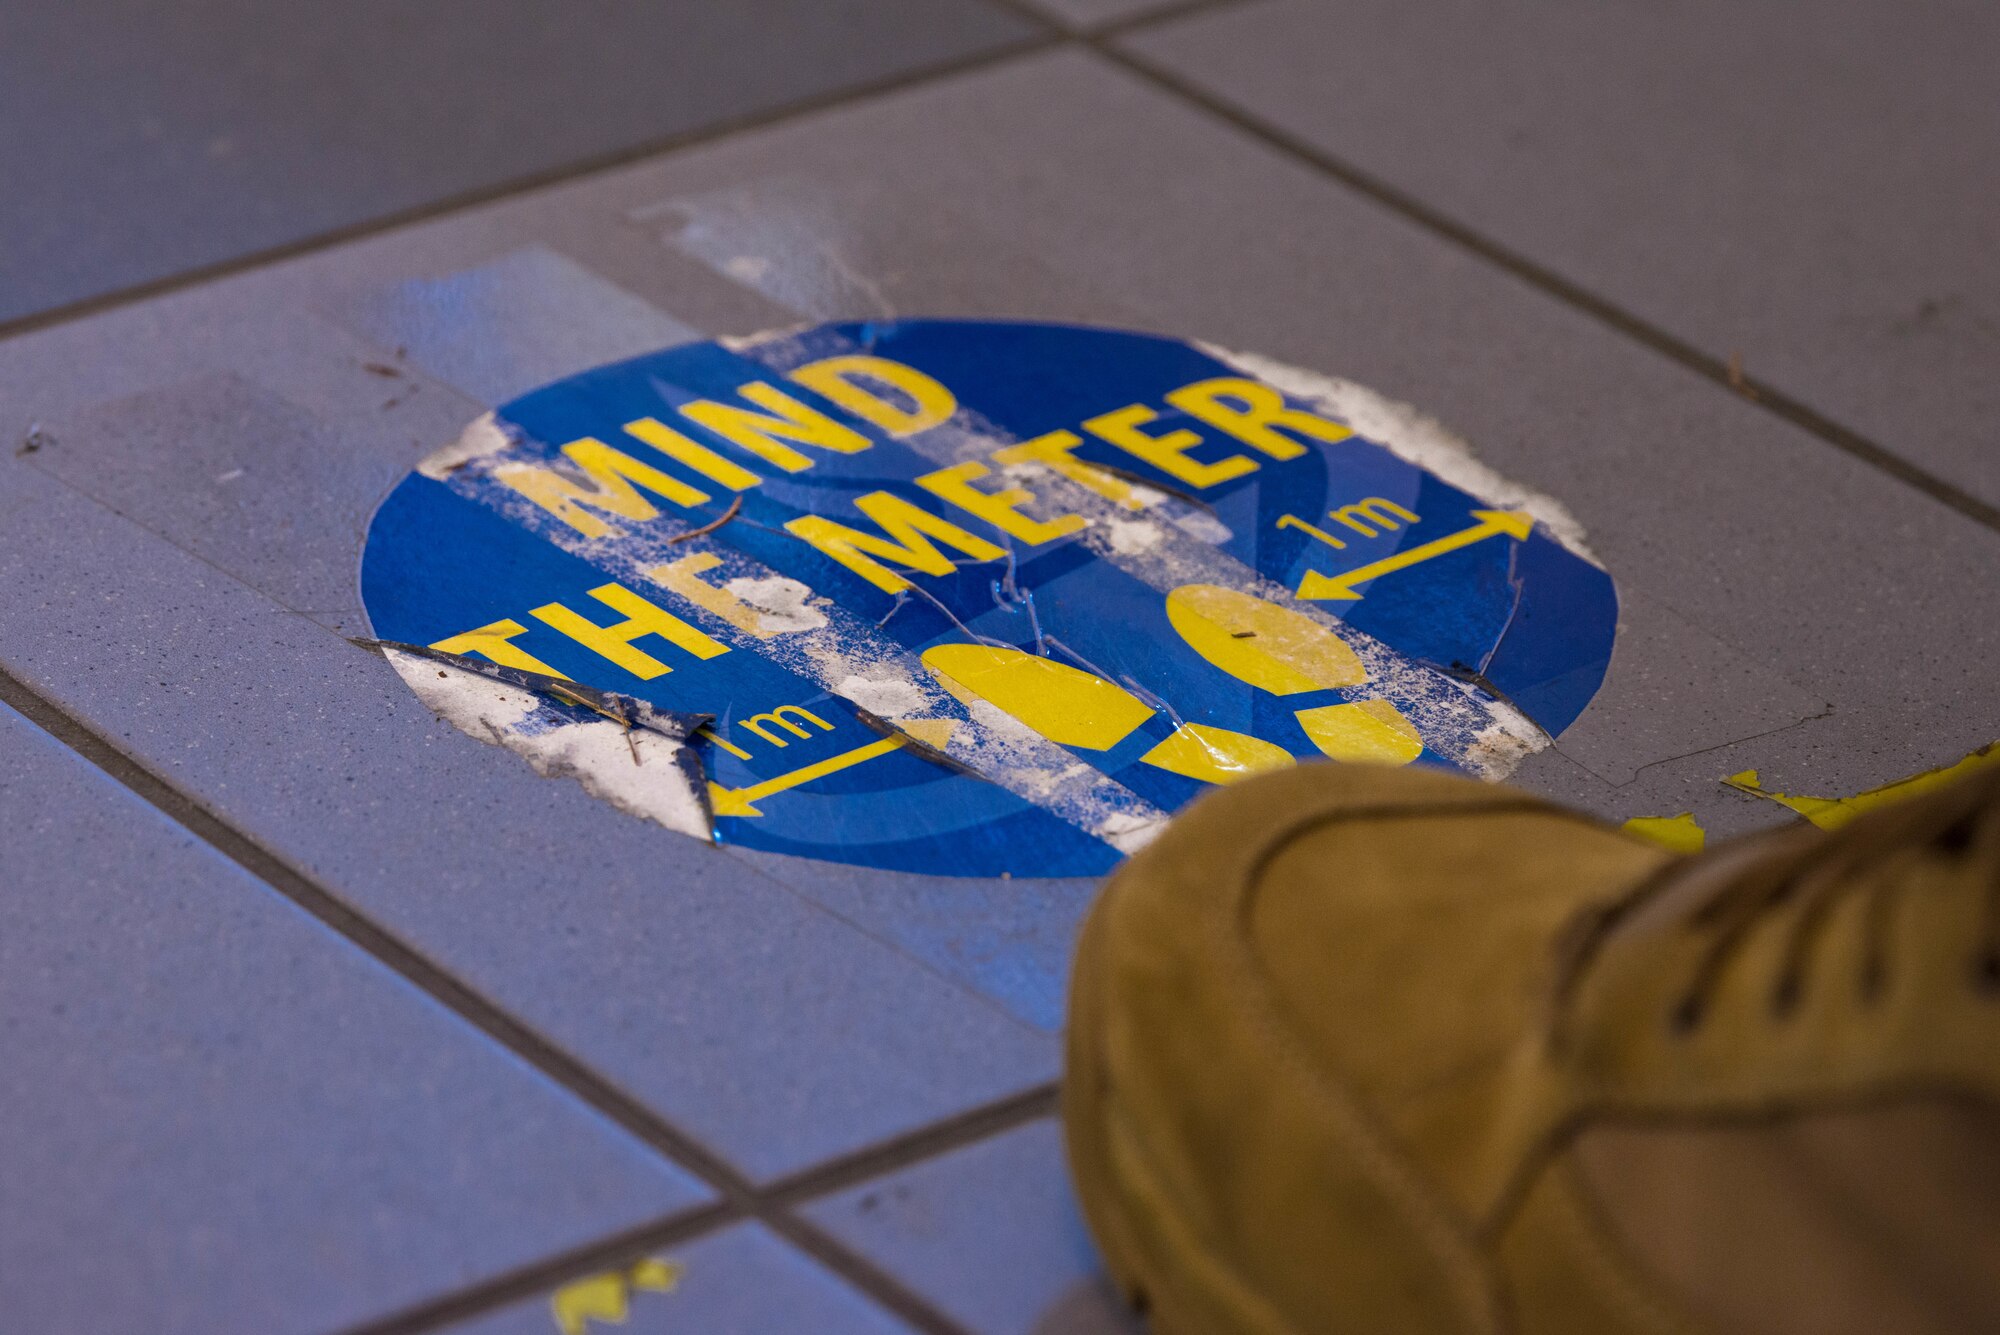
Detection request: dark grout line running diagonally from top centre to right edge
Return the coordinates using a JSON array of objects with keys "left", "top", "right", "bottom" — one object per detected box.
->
[{"left": 1088, "top": 32, "right": 2000, "bottom": 530}]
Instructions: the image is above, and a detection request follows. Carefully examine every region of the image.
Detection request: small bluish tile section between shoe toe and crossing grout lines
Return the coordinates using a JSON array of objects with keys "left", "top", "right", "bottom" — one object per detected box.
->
[{"left": 806, "top": 1121, "right": 1140, "bottom": 1335}]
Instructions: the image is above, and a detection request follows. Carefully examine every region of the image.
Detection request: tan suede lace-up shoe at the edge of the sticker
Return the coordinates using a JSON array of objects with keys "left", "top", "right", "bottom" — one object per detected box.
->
[{"left": 1064, "top": 765, "right": 2000, "bottom": 1335}]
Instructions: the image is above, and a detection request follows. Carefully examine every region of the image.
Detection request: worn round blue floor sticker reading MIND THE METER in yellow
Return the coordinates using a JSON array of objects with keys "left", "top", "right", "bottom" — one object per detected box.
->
[{"left": 362, "top": 320, "right": 1618, "bottom": 877}]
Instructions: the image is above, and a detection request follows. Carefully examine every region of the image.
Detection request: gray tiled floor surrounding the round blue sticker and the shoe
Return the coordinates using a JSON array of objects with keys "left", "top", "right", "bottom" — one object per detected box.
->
[{"left": 0, "top": 0, "right": 2000, "bottom": 1335}]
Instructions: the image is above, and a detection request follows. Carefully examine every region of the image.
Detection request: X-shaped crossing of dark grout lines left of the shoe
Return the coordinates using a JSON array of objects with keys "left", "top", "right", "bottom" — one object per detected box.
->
[{"left": 0, "top": 668, "right": 1054, "bottom": 1335}]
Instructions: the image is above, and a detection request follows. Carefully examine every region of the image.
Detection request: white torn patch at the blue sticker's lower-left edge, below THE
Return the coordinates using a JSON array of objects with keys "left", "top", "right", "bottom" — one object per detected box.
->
[{"left": 384, "top": 650, "right": 708, "bottom": 841}]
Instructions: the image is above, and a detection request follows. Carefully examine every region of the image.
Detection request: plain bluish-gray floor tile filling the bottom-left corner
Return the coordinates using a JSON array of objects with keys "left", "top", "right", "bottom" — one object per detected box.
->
[{"left": 0, "top": 707, "right": 704, "bottom": 1335}]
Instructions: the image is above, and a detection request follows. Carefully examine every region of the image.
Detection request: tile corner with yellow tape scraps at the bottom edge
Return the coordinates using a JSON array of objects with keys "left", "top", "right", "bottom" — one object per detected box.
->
[{"left": 448, "top": 1223, "right": 908, "bottom": 1335}]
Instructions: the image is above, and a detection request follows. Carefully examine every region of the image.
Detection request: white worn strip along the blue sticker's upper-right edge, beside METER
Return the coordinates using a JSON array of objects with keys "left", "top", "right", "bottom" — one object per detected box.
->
[{"left": 1196, "top": 344, "right": 1604, "bottom": 566}]
